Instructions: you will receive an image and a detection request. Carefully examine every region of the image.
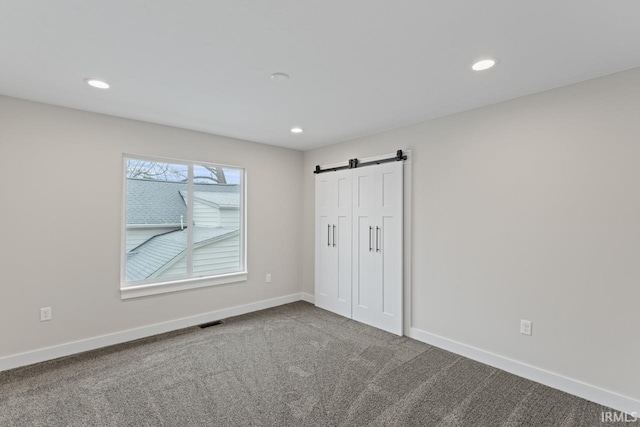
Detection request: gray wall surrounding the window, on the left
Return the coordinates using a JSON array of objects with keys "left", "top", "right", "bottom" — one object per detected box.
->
[{"left": 0, "top": 97, "right": 303, "bottom": 357}]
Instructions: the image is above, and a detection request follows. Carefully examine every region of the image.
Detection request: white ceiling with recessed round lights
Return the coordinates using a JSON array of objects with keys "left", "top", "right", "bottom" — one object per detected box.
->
[{"left": 0, "top": 0, "right": 640, "bottom": 150}]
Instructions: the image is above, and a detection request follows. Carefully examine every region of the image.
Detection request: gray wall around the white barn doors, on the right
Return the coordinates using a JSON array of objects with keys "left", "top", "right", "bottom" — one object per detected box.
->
[{"left": 303, "top": 69, "right": 640, "bottom": 399}]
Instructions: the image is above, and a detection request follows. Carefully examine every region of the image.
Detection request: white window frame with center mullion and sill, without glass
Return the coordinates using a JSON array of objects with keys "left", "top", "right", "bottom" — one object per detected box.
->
[{"left": 120, "top": 153, "right": 248, "bottom": 299}]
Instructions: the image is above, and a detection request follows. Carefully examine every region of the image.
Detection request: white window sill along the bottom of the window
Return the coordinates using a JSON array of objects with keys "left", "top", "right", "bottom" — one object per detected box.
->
[{"left": 120, "top": 271, "right": 247, "bottom": 299}]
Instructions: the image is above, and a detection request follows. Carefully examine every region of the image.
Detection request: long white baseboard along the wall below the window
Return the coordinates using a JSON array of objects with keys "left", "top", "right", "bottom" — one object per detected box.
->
[{"left": 0, "top": 293, "right": 308, "bottom": 371}]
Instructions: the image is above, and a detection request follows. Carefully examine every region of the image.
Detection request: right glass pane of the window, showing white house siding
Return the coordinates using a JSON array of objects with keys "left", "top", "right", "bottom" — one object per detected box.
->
[{"left": 191, "top": 165, "right": 243, "bottom": 276}]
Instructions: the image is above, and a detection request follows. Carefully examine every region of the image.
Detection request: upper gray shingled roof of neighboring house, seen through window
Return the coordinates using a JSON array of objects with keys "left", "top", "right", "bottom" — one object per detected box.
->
[{"left": 127, "top": 178, "right": 240, "bottom": 225}]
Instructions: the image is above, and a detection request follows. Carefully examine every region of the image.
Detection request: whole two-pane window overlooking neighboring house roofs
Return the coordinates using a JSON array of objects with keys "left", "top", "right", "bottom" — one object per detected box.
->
[{"left": 121, "top": 156, "right": 246, "bottom": 298}]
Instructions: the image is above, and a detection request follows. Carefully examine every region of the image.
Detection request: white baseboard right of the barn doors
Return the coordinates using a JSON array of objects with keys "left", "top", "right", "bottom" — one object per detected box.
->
[{"left": 408, "top": 328, "right": 640, "bottom": 417}]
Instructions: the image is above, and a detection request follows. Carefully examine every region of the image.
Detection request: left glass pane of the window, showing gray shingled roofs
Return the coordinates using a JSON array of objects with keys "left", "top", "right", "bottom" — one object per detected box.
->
[{"left": 125, "top": 159, "right": 188, "bottom": 282}]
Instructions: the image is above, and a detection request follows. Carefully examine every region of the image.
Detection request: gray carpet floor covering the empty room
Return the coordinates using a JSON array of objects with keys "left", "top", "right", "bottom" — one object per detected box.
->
[{"left": 0, "top": 302, "right": 630, "bottom": 427}]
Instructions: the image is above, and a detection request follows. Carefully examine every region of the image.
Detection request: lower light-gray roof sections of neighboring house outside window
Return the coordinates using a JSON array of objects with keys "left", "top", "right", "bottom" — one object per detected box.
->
[{"left": 126, "top": 227, "right": 240, "bottom": 282}]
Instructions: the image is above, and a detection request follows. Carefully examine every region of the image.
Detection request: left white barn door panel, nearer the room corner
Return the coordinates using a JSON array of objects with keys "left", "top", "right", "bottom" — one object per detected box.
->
[{"left": 315, "top": 170, "right": 352, "bottom": 318}]
